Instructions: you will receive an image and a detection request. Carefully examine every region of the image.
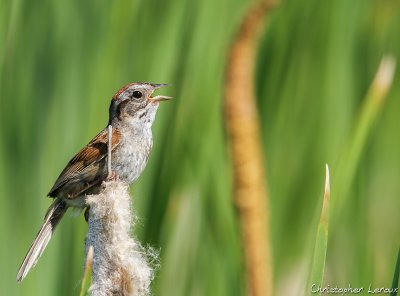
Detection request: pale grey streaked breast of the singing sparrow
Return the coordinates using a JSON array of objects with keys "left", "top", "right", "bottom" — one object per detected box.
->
[{"left": 111, "top": 128, "right": 153, "bottom": 184}]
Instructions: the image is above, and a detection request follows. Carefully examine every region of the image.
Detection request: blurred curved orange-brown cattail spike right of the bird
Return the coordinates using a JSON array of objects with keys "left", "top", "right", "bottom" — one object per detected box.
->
[{"left": 224, "top": 1, "right": 274, "bottom": 296}]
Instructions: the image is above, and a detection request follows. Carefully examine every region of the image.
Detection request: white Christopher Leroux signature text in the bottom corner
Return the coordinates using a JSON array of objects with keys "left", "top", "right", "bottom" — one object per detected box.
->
[{"left": 311, "top": 284, "right": 399, "bottom": 295}]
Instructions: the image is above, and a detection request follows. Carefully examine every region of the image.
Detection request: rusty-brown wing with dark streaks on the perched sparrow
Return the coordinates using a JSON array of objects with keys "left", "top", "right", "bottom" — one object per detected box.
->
[{"left": 47, "top": 127, "right": 121, "bottom": 197}]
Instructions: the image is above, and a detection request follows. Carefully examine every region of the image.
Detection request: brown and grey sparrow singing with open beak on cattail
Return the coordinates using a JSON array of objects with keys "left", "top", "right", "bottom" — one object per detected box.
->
[{"left": 17, "top": 82, "right": 171, "bottom": 283}]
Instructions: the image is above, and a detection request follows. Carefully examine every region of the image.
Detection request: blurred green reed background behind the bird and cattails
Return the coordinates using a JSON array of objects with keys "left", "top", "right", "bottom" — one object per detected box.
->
[{"left": 0, "top": 0, "right": 400, "bottom": 296}]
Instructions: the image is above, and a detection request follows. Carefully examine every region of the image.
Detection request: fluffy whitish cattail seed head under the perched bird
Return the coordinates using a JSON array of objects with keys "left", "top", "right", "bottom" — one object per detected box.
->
[{"left": 85, "top": 181, "right": 155, "bottom": 296}]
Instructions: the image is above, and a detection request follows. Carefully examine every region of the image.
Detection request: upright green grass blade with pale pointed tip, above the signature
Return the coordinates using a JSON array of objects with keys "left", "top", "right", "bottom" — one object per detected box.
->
[{"left": 306, "top": 165, "right": 330, "bottom": 294}]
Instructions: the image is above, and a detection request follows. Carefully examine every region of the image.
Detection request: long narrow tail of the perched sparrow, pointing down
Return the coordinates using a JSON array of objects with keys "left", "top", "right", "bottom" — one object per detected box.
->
[{"left": 17, "top": 198, "right": 68, "bottom": 283}]
